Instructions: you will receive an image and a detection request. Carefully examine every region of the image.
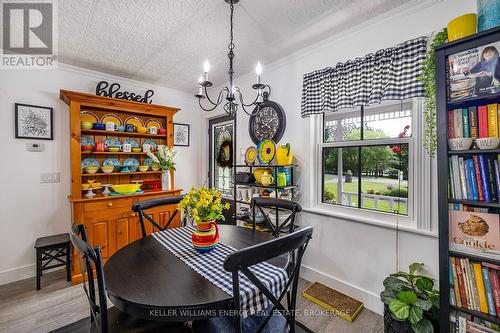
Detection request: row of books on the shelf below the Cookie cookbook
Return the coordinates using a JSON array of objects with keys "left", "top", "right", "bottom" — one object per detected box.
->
[{"left": 450, "top": 257, "right": 500, "bottom": 317}]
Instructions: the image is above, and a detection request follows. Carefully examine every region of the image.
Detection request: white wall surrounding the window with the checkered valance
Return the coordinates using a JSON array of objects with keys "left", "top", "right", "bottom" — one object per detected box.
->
[{"left": 201, "top": 0, "right": 476, "bottom": 313}]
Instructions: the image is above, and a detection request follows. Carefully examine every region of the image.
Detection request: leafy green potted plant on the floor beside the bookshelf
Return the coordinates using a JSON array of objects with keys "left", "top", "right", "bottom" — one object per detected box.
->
[{"left": 380, "top": 263, "right": 439, "bottom": 333}]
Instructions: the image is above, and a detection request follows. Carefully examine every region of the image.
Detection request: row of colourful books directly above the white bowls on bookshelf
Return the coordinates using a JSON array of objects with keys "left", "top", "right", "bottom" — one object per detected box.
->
[{"left": 448, "top": 103, "right": 500, "bottom": 139}]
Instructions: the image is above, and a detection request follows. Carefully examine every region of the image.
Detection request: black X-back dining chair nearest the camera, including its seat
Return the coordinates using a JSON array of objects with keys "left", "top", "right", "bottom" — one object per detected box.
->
[{"left": 193, "top": 227, "right": 313, "bottom": 333}]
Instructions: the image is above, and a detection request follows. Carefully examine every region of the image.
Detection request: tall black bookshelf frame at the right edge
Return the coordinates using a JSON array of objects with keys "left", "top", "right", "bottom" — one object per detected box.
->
[{"left": 436, "top": 27, "right": 500, "bottom": 332}]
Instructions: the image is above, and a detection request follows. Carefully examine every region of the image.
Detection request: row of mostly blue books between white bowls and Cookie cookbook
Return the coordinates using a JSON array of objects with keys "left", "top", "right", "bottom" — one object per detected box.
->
[{"left": 448, "top": 154, "right": 500, "bottom": 203}]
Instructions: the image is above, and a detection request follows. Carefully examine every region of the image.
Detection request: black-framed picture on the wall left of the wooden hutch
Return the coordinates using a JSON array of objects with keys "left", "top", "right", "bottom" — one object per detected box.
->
[{"left": 15, "top": 103, "right": 54, "bottom": 140}]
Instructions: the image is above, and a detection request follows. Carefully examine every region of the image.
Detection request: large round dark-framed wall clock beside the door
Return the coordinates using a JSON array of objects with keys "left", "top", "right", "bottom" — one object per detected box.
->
[{"left": 248, "top": 92, "right": 286, "bottom": 144}]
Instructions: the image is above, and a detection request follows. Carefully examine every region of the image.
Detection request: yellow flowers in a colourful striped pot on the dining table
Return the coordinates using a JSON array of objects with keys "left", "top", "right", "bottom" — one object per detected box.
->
[{"left": 178, "top": 187, "right": 230, "bottom": 253}]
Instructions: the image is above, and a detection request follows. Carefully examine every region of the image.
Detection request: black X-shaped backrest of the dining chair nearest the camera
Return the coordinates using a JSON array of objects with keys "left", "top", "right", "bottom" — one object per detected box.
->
[{"left": 224, "top": 227, "right": 313, "bottom": 332}]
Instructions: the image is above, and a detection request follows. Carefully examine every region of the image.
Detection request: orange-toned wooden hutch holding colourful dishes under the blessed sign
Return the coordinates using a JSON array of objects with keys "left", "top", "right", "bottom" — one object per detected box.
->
[{"left": 60, "top": 90, "right": 182, "bottom": 284}]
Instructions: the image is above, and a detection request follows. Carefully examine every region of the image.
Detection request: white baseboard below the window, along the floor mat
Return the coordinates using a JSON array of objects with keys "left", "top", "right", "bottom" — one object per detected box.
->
[{"left": 300, "top": 265, "right": 384, "bottom": 315}]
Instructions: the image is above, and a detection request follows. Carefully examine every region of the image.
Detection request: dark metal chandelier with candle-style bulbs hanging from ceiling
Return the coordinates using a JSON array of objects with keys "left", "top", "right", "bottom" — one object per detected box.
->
[{"left": 194, "top": 0, "right": 271, "bottom": 116}]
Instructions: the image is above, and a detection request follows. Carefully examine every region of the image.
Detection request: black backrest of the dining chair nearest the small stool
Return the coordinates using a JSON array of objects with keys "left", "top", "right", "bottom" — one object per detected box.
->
[{"left": 70, "top": 224, "right": 108, "bottom": 333}]
